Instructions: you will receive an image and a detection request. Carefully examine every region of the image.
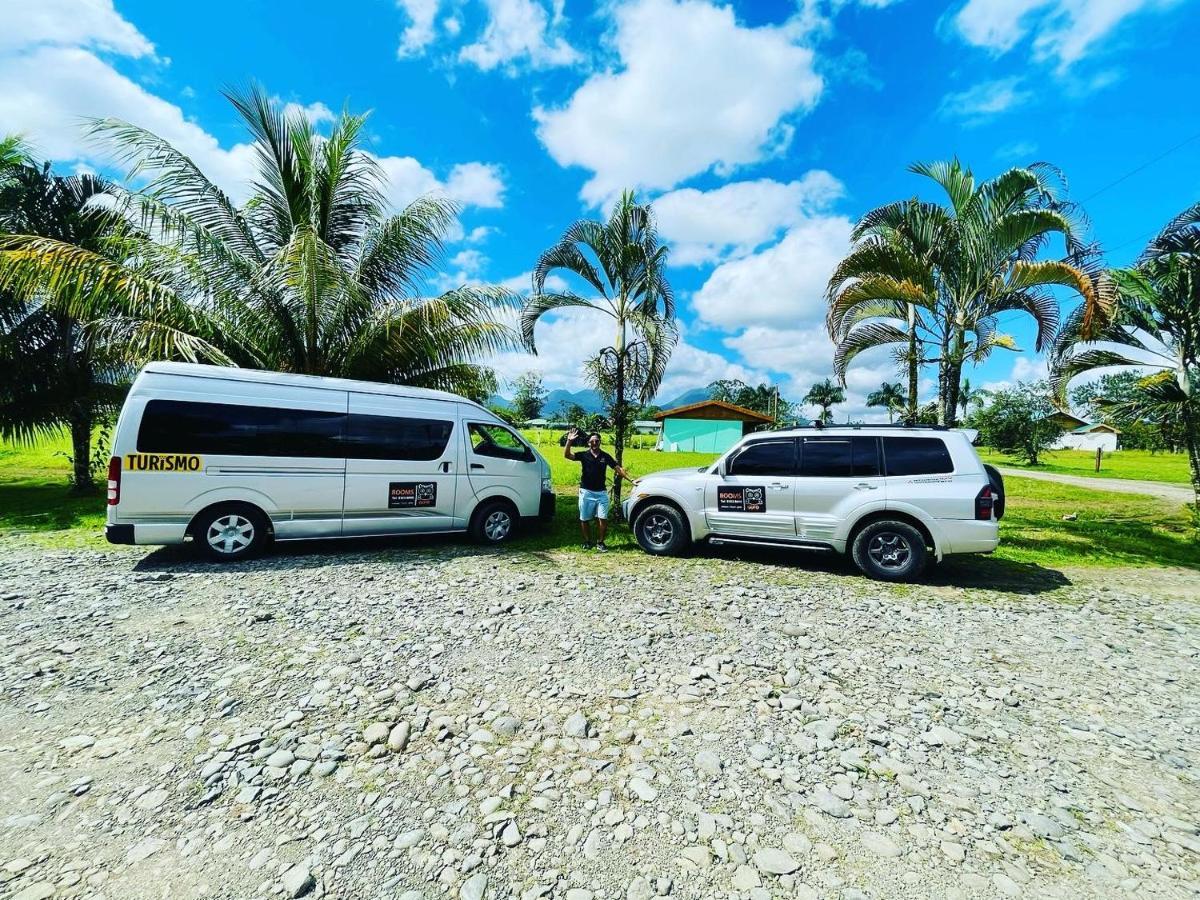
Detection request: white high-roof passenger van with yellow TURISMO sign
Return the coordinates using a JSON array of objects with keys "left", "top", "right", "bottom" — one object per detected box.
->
[{"left": 104, "top": 362, "right": 554, "bottom": 560}]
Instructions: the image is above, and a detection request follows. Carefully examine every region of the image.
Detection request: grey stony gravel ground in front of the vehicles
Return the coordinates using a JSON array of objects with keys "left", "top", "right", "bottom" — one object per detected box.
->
[{"left": 0, "top": 538, "right": 1200, "bottom": 900}]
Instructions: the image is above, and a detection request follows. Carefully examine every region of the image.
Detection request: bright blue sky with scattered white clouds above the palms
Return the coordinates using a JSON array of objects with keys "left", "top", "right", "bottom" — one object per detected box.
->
[{"left": 0, "top": 0, "right": 1200, "bottom": 415}]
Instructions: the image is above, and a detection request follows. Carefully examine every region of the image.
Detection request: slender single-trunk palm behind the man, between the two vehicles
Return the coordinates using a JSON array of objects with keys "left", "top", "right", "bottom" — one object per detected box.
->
[{"left": 521, "top": 191, "right": 679, "bottom": 509}]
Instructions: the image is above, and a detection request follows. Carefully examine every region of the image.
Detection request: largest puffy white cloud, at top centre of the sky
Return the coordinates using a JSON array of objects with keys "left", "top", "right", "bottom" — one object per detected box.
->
[{"left": 534, "top": 0, "right": 822, "bottom": 204}]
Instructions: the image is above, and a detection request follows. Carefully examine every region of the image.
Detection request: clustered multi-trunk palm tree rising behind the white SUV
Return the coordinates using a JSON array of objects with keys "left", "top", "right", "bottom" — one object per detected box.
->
[{"left": 826, "top": 160, "right": 1092, "bottom": 425}]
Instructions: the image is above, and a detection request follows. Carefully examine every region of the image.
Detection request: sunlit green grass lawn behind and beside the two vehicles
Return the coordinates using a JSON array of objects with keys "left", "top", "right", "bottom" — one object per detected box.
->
[{"left": 0, "top": 437, "right": 1200, "bottom": 569}]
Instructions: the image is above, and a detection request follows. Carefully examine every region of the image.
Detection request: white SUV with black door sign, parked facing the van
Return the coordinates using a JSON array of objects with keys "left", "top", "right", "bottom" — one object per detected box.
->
[{"left": 622, "top": 425, "right": 1004, "bottom": 581}]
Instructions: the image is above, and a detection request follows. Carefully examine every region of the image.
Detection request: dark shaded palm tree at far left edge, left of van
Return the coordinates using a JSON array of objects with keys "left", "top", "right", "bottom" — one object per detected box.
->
[{"left": 0, "top": 163, "right": 128, "bottom": 493}]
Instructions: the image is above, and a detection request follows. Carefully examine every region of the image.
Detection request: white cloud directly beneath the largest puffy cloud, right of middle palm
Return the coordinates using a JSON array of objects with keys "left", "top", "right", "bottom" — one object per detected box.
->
[{"left": 654, "top": 169, "right": 845, "bottom": 265}]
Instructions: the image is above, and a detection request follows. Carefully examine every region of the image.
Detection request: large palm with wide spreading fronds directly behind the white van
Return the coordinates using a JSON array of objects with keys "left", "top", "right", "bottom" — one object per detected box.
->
[{"left": 0, "top": 86, "right": 520, "bottom": 398}]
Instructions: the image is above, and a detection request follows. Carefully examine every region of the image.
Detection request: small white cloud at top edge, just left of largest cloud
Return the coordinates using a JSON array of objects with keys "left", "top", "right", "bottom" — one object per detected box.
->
[{"left": 458, "top": 0, "right": 582, "bottom": 72}]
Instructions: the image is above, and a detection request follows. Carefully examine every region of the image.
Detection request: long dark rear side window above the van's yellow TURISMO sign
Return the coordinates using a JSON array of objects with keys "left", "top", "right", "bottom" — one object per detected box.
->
[{"left": 138, "top": 400, "right": 346, "bottom": 458}]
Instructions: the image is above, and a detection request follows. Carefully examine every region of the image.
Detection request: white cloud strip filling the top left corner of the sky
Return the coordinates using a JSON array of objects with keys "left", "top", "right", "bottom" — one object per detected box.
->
[{"left": 0, "top": 0, "right": 154, "bottom": 58}]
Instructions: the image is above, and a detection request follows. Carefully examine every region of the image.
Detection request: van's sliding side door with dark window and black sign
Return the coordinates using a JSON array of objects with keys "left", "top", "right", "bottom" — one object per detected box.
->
[{"left": 342, "top": 392, "right": 466, "bottom": 535}]
